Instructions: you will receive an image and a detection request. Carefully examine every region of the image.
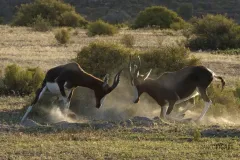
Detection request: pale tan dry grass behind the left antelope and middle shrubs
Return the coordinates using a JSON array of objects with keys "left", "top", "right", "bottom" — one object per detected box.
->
[{"left": 0, "top": 26, "right": 183, "bottom": 70}]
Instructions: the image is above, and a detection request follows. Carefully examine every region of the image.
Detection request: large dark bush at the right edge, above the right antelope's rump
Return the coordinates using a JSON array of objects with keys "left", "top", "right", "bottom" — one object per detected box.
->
[{"left": 187, "top": 14, "right": 240, "bottom": 50}]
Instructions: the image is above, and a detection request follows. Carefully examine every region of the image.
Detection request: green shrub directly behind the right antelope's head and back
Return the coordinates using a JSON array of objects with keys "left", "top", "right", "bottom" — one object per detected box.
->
[{"left": 140, "top": 45, "right": 199, "bottom": 74}]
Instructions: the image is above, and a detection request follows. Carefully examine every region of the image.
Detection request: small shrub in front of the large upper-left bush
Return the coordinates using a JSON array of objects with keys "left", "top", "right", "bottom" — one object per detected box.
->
[{"left": 32, "top": 15, "right": 51, "bottom": 32}]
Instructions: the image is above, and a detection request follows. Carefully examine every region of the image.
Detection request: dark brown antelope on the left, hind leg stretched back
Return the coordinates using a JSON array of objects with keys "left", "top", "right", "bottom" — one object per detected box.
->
[{"left": 21, "top": 63, "right": 122, "bottom": 123}]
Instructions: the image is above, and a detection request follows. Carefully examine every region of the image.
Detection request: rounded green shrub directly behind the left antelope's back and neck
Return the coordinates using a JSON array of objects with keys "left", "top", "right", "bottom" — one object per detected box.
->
[{"left": 76, "top": 42, "right": 130, "bottom": 77}]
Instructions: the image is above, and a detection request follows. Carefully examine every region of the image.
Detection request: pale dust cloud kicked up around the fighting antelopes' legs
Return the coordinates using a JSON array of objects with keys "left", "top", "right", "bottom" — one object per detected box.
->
[{"left": 40, "top": 77, "right": 240, "bottom": 125}]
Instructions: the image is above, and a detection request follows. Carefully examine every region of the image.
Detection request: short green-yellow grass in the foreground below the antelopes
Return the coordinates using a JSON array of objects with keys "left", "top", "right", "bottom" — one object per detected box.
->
[{"left": 0, "top": 97, "right": 240, "bottom": 160}]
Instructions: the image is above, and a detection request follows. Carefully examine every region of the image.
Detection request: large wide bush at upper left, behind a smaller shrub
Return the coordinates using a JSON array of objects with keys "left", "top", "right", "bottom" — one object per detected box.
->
[{"left": 12, "top": 0, "right": 87, "bottom": 27}]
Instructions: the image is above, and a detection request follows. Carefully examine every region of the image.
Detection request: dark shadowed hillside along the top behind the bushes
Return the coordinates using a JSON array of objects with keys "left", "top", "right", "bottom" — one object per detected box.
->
[{"left": 0, "top": 0, "right": 240, "bottom": 23}]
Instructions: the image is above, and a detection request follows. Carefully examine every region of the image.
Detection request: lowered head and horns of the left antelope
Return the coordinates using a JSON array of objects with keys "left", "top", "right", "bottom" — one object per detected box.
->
[{"left": 95, "top": 69, "right": 123, "bottom": 108}]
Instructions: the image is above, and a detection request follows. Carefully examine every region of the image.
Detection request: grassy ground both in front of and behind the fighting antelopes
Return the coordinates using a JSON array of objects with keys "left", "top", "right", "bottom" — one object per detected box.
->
[{"left": 0, "top": 26, "right": 240, "bottom": 159}]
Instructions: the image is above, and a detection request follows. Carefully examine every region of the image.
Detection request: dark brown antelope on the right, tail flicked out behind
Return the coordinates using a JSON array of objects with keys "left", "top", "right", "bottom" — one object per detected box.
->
[{"left": 129, "top": 57, "right": 225, "bottom": 121}]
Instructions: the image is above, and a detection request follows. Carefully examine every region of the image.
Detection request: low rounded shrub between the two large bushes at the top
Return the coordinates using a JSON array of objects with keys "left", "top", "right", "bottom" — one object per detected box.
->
[{"left": 88, "top": 20, "right": 117, "bottom": 36}]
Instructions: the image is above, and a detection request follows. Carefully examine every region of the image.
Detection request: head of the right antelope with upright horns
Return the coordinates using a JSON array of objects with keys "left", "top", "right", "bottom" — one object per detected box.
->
[{"left": 129, "top": 56, "right": 152, "bottom": 103}]
